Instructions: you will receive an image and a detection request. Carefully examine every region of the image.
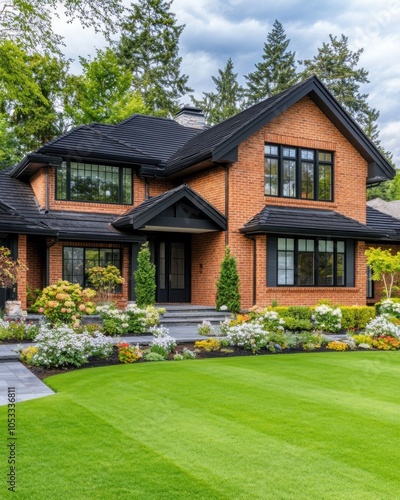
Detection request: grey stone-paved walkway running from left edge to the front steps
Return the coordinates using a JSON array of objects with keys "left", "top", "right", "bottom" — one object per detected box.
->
[{"left": 0, "top": 326, "right": 205, "bottom": 406}]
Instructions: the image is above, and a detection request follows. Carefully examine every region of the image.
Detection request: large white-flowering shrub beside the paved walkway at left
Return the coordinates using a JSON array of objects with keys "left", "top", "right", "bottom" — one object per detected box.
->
[{"left": 32, "top": 325, "right": 113, "bottom": 368}]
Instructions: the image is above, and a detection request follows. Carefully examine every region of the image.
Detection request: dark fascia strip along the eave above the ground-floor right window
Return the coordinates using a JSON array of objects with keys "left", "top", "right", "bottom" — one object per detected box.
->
[{"left": 239, "top": 224, "right": 387, "bottom": 241}]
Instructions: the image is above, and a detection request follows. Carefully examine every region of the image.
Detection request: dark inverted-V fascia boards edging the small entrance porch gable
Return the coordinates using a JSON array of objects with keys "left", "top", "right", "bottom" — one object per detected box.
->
[{"left": 118, "top": 185, "right": 226, "bottom": 230}]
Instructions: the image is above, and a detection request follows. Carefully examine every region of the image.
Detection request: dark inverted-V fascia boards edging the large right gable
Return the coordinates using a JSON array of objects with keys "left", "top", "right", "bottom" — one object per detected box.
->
[{"left": 212, "top": 76, "right": 395, "bottom": 179}]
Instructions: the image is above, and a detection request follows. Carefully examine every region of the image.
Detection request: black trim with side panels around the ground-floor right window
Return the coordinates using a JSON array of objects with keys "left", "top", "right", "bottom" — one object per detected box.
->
[{"left": 266, "top": 238, "right": 355, "bottom": 289}]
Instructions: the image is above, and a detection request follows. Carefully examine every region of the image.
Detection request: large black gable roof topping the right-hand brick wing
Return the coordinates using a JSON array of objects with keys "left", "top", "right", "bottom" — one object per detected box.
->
[{"left": 166, "top": 76, "right": 395, "bottom": 183}]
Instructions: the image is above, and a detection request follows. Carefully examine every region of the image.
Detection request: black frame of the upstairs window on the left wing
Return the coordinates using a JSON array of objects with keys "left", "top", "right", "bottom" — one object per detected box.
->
[{"left": 54, "top": 160, "right": 134, "bottom": 206}]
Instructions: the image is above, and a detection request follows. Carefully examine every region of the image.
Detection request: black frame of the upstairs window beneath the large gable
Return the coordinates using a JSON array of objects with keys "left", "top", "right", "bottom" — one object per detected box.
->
[{"left": 264, "top": 142, "right": 335, "bottom": 203}]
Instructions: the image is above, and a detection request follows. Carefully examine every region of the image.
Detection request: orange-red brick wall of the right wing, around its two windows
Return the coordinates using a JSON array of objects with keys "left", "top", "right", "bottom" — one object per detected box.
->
[{"left": 185, "top": 98, "right": 367, "bottom": 308}]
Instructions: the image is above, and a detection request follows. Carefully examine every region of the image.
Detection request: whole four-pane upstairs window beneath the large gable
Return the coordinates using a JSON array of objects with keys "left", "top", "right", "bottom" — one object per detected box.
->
[{"left": 264, "top": 144, "right": 333, "bottom": 201}]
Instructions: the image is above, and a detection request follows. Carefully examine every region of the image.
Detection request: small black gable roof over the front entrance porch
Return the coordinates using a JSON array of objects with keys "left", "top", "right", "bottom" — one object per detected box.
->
[{"left": 113, "top": 184, "right": 226, "bottom": 232}]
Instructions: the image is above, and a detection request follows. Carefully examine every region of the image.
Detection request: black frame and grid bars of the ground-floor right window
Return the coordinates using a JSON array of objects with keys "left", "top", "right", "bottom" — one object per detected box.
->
[{"left": 274, "top": 235, "right": 346, "bottom": 288}]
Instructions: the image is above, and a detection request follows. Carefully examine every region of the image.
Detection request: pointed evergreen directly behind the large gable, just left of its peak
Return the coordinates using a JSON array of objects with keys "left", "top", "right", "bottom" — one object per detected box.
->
[{"left": 245, "top": 20, "right": 297, "bottom": 105}]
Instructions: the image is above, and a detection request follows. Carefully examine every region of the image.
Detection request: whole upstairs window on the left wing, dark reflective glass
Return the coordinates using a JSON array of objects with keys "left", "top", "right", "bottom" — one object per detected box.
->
[{"left": 56, "top": 161, "right": 133, "bottom": 205}]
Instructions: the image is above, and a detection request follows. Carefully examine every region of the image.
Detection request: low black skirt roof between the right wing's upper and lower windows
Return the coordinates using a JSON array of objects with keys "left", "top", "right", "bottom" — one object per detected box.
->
[{"left": 240, "top": 205, "right": 386, "bottom": 240}]
